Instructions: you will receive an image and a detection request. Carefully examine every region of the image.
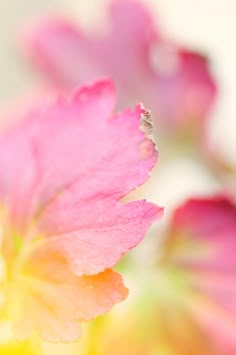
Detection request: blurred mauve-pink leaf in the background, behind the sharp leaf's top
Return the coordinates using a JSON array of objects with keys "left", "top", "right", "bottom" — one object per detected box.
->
[{"left": 24, "top": 0, "right": 216, "bottom": 135}]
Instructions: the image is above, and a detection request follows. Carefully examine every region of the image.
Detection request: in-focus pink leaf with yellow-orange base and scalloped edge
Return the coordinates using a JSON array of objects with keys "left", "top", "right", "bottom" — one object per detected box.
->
[{"left": 0, "top": 82, "right": 162, "bottom": 341}]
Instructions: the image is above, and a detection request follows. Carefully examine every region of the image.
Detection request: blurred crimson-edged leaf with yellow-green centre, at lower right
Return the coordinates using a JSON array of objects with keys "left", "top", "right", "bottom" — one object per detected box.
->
[{"left": 87, "top": 196, "right": 236, "bottom": 355}]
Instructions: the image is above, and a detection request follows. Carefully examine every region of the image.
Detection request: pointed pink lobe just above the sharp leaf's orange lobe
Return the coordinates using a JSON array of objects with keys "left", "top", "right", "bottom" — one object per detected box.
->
[{"left": 40, "top": 199, "right": 162, "bottom": 275}]
